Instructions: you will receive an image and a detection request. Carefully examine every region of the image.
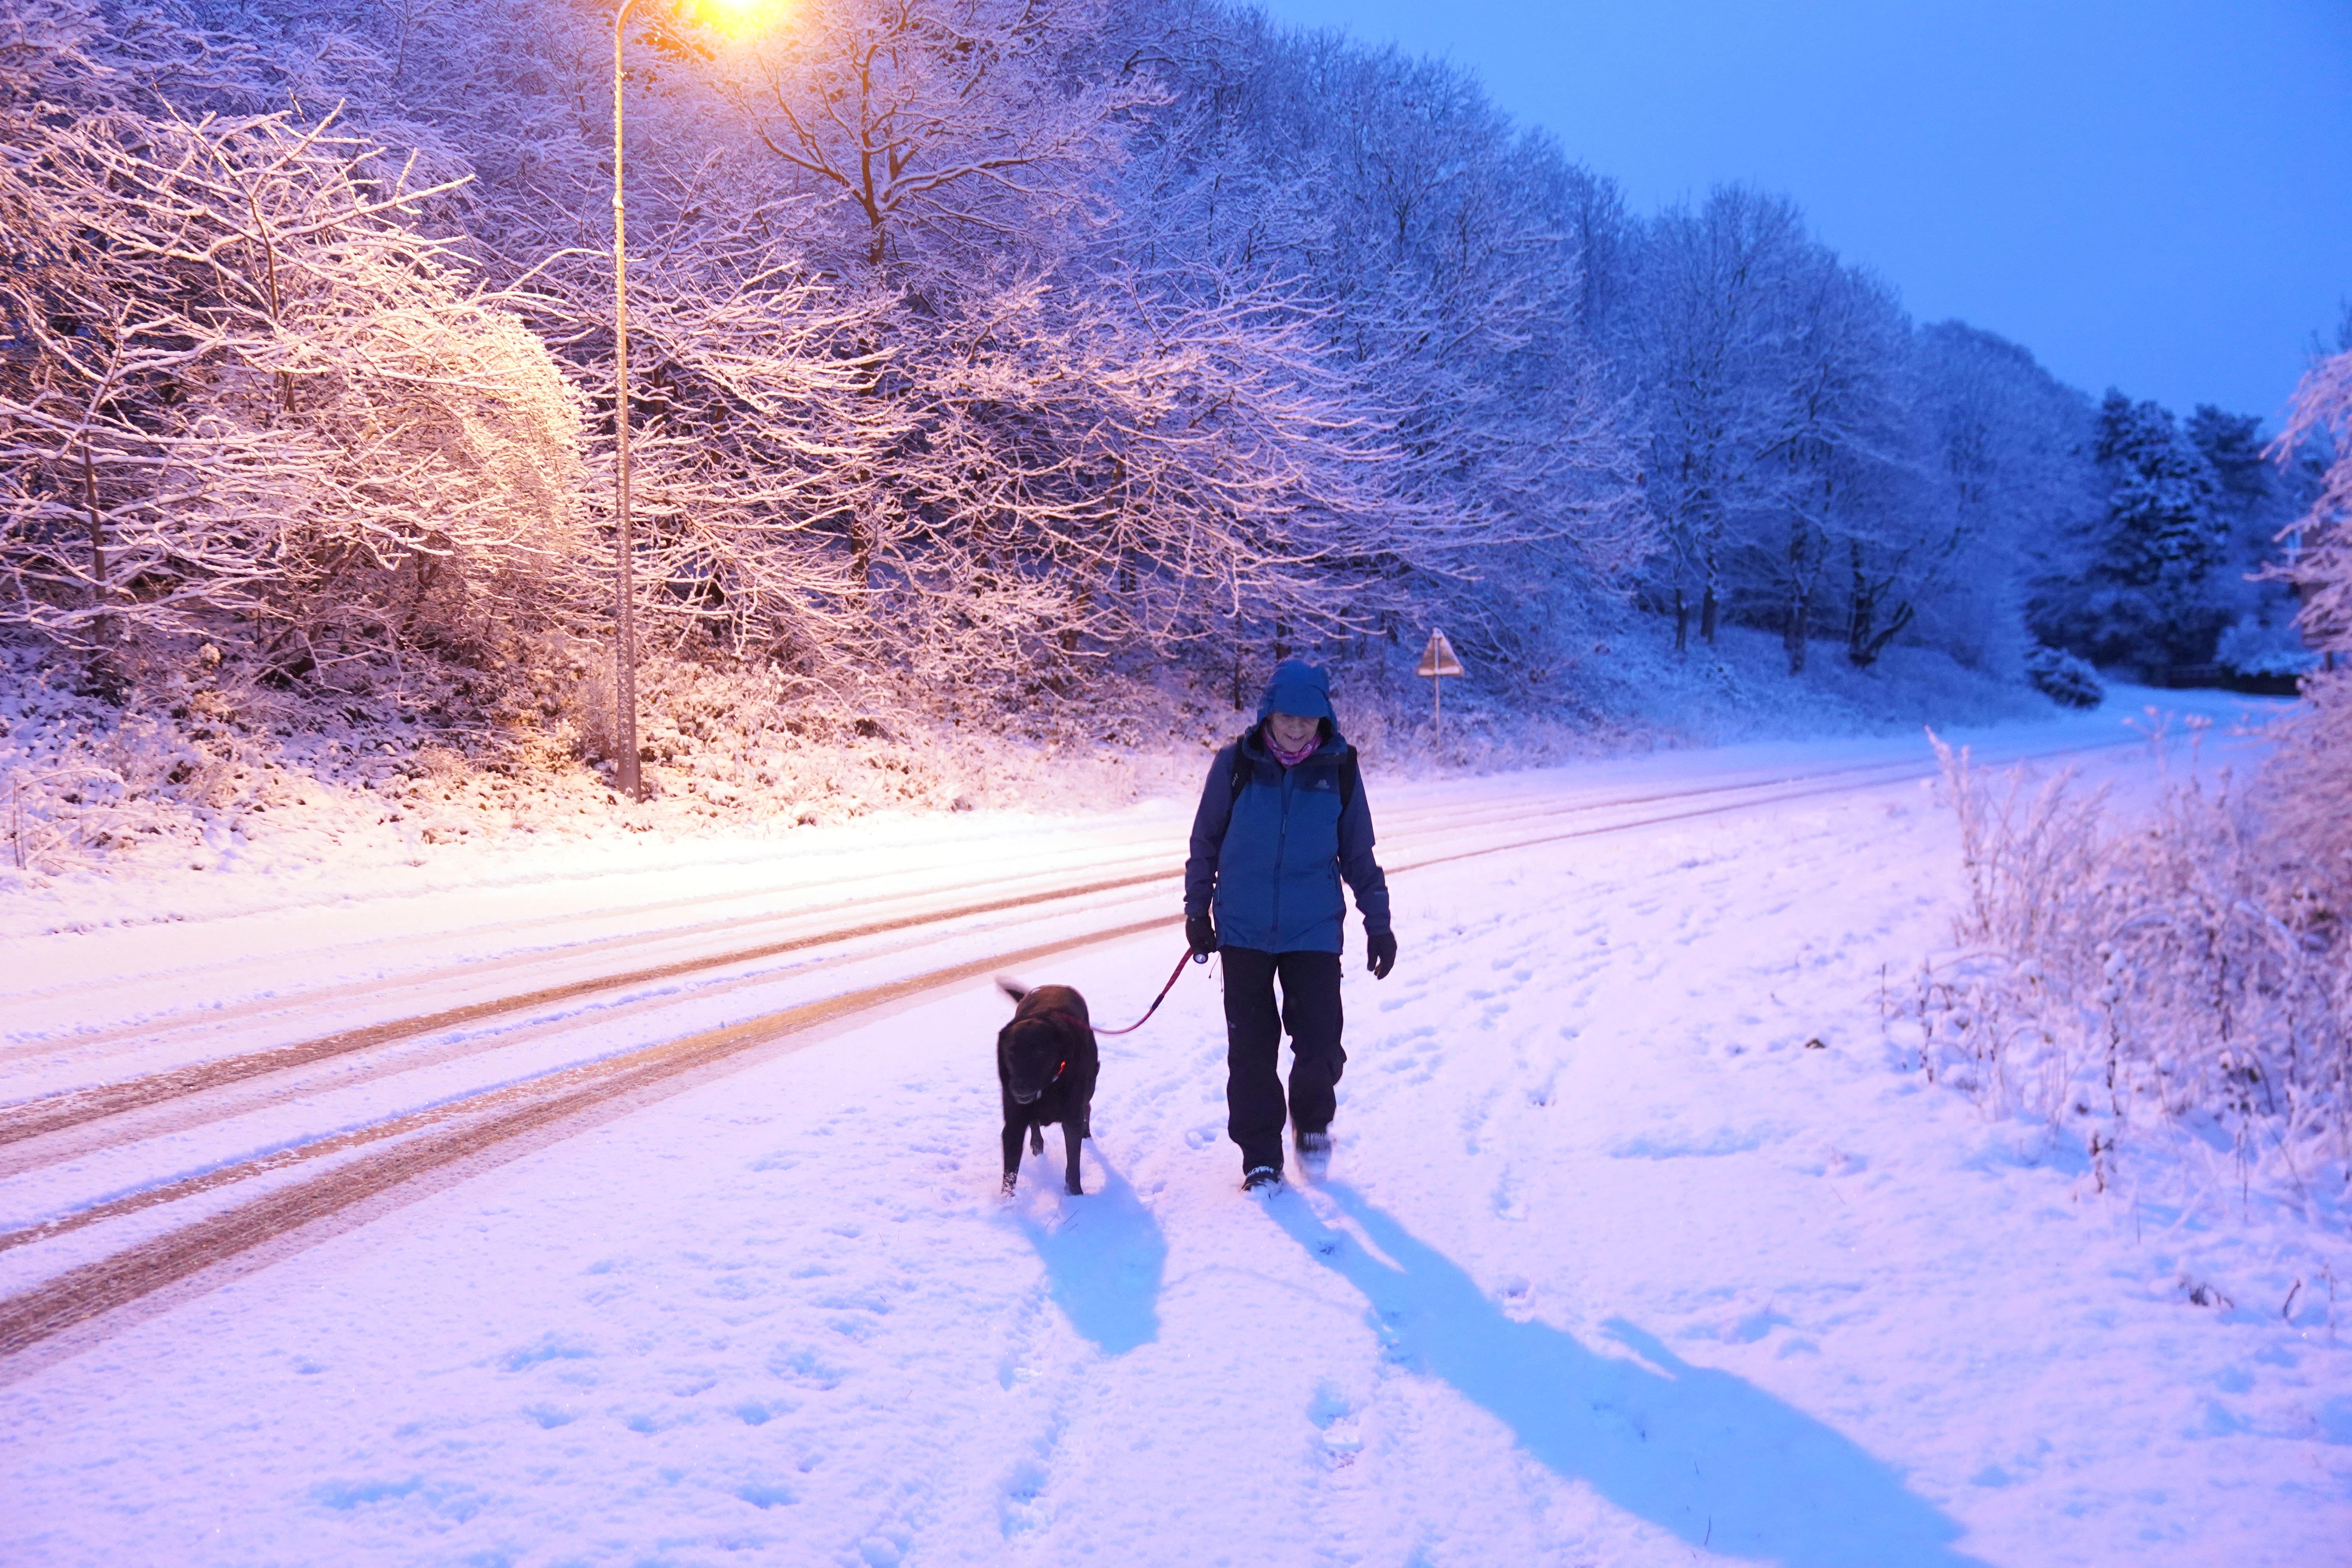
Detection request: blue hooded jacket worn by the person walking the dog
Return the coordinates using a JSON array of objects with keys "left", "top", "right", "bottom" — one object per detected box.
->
[{"left": 1183, "top": 658, "right": 1388, "bottom": 952}]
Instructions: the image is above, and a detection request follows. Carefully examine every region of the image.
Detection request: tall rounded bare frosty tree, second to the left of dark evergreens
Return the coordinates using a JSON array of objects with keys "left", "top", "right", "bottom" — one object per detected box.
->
[{"left": 1606, "top": 186, "right": 1957, "bottom": 672}]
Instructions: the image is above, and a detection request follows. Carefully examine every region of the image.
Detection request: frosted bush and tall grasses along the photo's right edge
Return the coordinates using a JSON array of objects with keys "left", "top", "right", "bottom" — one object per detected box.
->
[{"left": 1919, "top": 353, "right": 2352, "bottom": 1201}]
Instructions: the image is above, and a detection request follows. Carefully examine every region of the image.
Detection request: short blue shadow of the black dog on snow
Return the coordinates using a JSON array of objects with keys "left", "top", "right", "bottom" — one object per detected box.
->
[{"left": 1014, "top": 1143, "right": 1169, "bottom": 1356}]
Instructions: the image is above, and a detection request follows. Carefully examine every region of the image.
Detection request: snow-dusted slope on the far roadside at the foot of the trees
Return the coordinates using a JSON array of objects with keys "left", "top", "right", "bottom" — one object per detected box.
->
[{"left": 0, "top": 613, "right": 2060, "bottom": 896}]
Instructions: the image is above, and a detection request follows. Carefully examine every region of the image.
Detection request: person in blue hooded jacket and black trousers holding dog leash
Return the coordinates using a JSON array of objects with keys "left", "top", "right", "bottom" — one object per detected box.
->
[{"left": 1183, "top": 658, "right": 1397, "bottom": 1192}]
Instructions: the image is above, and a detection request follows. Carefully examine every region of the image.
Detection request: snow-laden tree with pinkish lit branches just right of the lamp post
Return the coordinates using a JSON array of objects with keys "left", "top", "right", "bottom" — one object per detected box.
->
[{"left": 687, "top": 2, "right": 1468, "bottom": 696}]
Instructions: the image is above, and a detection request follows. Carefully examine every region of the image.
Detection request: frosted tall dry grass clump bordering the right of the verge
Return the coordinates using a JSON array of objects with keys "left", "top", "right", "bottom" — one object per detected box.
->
[{"left": 1910, "top": 717, "right": 2352, "bottom": 1269}]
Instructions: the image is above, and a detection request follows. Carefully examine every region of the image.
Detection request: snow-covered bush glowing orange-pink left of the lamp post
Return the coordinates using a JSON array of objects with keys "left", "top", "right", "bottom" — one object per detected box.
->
[{"left": 0, "top": 4, "right": 590, "bottom": 689}]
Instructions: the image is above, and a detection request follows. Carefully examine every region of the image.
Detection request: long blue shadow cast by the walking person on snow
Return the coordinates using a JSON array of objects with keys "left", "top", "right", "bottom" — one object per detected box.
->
[{"left": 1268, "top": 1185, "right": 1983, "bottom": 1568}]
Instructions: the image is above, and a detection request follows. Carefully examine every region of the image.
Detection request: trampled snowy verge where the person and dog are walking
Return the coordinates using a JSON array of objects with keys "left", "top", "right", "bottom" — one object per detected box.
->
[{"left": 0, "top": 701, "right": 2352, "bottom": 1563}]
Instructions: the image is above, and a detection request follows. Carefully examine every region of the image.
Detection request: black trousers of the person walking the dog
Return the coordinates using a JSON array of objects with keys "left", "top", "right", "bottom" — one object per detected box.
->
[{"left": 1218, "top": 947, "right": 1348, "bottom": 1173}]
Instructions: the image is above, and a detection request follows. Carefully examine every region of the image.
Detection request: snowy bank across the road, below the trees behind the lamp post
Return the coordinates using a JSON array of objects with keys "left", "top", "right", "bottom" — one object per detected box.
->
[{"left": 0, "top": 618, "right": 2060, "bottom": 938}]
